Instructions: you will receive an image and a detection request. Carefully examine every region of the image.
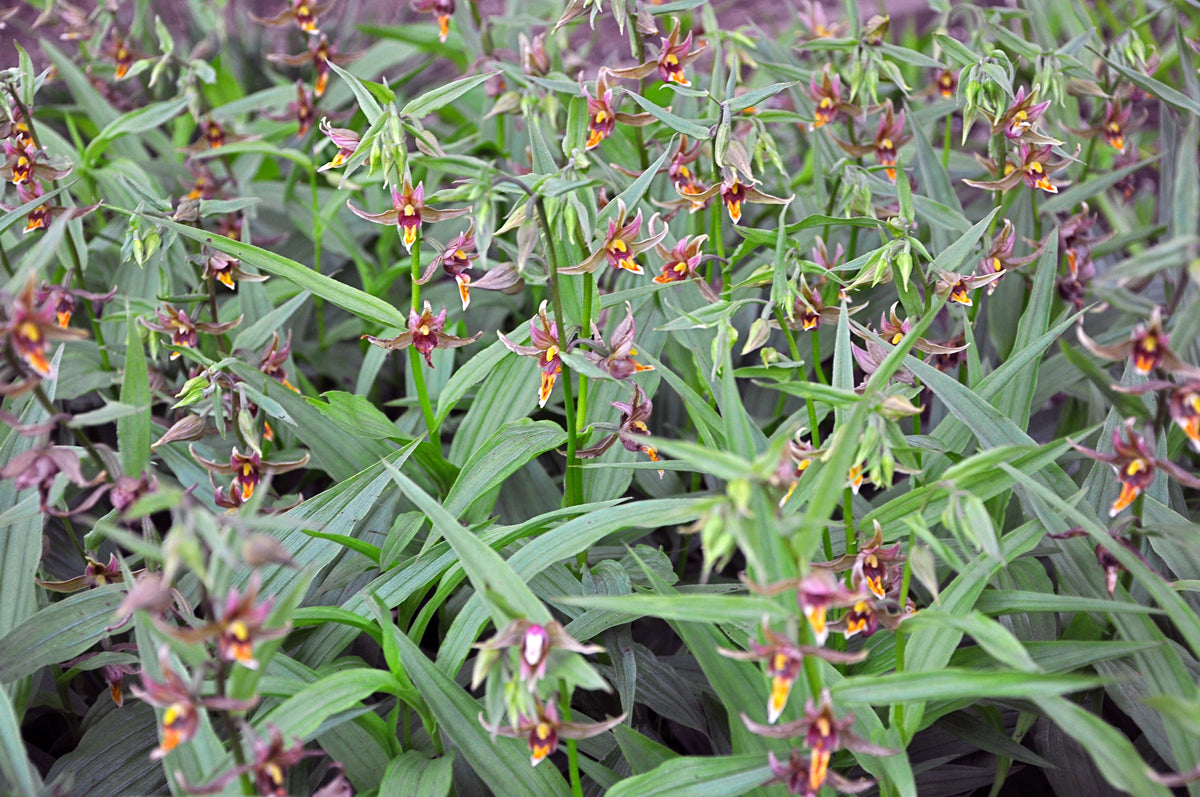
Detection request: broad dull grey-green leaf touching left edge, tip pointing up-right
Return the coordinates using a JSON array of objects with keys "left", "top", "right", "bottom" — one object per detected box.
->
[{"left": 0, "top": 585, "right": 124, "bottom": 683}]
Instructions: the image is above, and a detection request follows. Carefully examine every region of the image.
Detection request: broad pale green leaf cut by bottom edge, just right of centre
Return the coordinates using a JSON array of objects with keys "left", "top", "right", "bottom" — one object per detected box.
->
[{"left": 607, "top": 754, "right": 774, "bottom": 797}]
